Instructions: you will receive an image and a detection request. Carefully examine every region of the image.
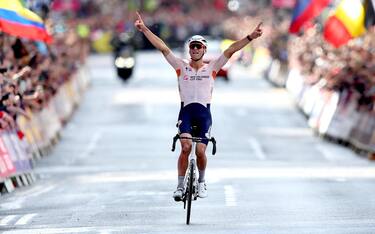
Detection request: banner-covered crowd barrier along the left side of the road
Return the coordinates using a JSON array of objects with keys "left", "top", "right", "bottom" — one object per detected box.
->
[{"left": 0, "top": 66, "right": 89, "bottom": 194}]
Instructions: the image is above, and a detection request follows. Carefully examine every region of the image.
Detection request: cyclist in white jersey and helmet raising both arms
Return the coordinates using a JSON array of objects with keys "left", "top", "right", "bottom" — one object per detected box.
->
[{"left": 134, "top": 12, "right": 262, "bottom": 201}]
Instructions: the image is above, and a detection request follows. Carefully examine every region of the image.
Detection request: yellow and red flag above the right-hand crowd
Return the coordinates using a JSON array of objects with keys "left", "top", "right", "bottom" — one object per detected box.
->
[{"left": 324, "top": 0, "right": 366, "bottom": 48}]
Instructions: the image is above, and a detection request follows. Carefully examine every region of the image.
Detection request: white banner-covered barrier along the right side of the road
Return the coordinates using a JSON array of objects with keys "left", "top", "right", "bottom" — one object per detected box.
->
[{"left": 286, "top": 69, "right": 375, "bottom": 155}]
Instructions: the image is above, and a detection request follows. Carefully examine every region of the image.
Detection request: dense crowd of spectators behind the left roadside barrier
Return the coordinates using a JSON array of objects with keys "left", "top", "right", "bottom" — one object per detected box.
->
[{"left": 0, "top": 0, "right": 130, "bottom": 134}]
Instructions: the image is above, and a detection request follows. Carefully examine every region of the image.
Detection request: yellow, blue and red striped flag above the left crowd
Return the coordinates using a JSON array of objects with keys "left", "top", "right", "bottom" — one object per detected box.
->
[{"left": 0, "top": 0, "right": 52, "bottom": 43}]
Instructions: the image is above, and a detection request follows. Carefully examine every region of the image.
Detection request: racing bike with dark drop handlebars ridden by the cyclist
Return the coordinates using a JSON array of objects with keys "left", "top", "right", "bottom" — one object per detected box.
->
[{"left": 172, "top": 127, "right": 216, "bottom": 225}]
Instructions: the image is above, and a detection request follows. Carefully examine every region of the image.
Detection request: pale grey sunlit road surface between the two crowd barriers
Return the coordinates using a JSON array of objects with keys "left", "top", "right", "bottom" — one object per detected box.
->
[{"left": 0, "top": 52, "right": 375, "bottom": 234}]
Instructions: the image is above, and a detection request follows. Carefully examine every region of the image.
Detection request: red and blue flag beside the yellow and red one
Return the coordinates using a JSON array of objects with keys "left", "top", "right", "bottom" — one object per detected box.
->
[{"left": 289, "top": 0, "right": 331, "bottom": 33}]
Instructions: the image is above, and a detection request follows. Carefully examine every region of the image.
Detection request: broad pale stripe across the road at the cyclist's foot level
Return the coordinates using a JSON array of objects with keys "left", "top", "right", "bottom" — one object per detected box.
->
[{"left": 77, "top": 166, "right": 375, "bottom": 184}]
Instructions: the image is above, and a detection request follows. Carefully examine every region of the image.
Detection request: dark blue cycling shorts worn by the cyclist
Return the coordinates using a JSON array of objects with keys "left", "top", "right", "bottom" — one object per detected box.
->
[{"left": 177, "top": 103, "right": 212, "bottom": 145}]
